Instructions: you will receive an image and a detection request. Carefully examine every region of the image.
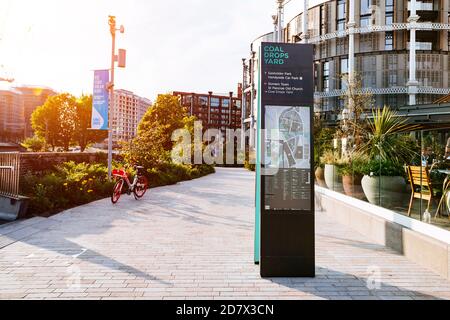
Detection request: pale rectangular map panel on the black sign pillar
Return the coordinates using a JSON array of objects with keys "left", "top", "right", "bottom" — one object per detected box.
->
[{"left": 265, "top": 106, "right": 311, "bottom": 170}]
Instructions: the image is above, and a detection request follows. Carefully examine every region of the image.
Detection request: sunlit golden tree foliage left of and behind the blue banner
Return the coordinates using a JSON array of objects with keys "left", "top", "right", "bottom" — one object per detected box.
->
[{"left": 31, "top": 93, "right": 106, "bottom": 151}]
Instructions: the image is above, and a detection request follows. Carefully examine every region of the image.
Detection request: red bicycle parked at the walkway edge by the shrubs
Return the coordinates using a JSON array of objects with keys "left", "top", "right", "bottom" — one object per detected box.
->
[{"left": 111, "top": 166, "right": 148, "bottom": 204}]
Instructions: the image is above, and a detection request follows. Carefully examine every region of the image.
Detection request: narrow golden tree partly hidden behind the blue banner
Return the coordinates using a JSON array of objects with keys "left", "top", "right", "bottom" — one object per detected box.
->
[{"left": 73, "top": 95, "right": 108, "bottom": 152}]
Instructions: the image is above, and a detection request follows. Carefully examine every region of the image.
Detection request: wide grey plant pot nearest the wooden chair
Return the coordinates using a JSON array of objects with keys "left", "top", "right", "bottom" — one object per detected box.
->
[{"left": 361, "top": 176, "right": 406, "bottom": 209}]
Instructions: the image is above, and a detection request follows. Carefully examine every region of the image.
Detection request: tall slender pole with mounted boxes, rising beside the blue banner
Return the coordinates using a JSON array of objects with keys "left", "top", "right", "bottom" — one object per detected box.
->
[{"left": 108, "top": 16, "right": 125, "bottom": 179}]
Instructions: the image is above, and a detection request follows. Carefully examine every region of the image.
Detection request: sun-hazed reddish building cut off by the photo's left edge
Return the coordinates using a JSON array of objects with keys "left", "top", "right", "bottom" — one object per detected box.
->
[{"left": 0, "top": 89, "right": 25, "bottom": 142}]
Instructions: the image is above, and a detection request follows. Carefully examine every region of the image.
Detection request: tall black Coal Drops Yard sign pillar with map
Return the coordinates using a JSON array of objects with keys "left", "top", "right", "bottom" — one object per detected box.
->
[{"left": 258, "top": 43, "right": 315, "bottom": 277}]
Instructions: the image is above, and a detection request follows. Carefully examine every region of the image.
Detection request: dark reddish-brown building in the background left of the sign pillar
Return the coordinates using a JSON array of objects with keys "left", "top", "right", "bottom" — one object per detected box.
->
[{"left": 172, "top": 86, "right": 242, "bottom": 131}]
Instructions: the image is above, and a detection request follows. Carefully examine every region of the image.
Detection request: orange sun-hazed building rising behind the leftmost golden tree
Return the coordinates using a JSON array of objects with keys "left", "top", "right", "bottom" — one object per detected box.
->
[{"left": 14, "top": 86, "right": 56, "bottom": 138}]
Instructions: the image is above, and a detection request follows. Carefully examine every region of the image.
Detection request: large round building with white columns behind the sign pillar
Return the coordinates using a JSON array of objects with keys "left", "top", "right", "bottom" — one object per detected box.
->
[{"left": 244, "top": 0, "right": 450, "bottom": 130}]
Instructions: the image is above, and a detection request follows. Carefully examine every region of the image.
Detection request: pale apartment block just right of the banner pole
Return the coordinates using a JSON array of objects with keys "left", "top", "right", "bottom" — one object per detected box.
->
[{"left": 111, "top": 89, "right": 152, "bottom": 143}]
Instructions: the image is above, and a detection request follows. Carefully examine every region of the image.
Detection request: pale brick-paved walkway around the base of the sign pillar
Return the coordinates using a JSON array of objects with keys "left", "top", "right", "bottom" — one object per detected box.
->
[{"left": 0, "top": 169, "right": 450, "bottom": 299}]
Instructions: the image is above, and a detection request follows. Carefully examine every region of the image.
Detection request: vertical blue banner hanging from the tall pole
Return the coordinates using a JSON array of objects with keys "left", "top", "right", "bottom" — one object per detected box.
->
[{"left": 91, "top": 70, "right": 109, "bottom": 130}]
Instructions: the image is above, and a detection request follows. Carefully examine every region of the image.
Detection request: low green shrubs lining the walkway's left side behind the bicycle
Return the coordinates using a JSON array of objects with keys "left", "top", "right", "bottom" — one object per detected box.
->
[{"left": 21, "top": 162, "right": 214, "bottom": 215}]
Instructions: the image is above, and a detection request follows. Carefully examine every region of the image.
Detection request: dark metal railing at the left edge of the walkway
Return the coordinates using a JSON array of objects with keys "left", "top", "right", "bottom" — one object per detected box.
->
[{"left": 0, "top": 152, "right": 20, "bottom": 198}]
